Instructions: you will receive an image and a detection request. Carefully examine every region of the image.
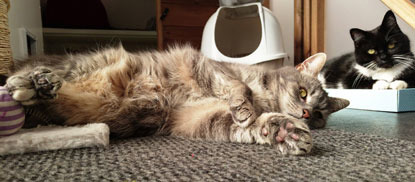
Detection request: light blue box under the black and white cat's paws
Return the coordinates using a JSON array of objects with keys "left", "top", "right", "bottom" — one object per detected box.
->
[{"left": 326, "top": 88, "right": 415, "bottom": 112}]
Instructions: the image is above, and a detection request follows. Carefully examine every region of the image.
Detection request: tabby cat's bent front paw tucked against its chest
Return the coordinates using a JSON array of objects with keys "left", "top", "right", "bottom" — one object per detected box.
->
[{"left": 230, "top": 98, "right": 257, "bottom": 128}]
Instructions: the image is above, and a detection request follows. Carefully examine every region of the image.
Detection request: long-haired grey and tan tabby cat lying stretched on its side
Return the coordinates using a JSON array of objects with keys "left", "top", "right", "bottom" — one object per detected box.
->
[{"left": 6, "top": 46, "right": 349, "bottom": 154}]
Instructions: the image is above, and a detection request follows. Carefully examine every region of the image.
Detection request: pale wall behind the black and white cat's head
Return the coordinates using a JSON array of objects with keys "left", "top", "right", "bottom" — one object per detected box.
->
[{"left": 326, "top": 0, "right": 415, "bottom": 58}]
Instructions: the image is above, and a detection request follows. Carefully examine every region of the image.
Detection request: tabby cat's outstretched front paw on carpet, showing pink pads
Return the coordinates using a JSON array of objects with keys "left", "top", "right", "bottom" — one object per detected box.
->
[{"left": 257, "top": 113, "right": 313, "bottom": 155}]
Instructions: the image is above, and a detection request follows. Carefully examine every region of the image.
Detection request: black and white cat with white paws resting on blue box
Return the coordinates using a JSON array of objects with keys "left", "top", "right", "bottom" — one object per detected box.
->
[{"left": 319, "top": 11, "right": 415, "bottom": 89}]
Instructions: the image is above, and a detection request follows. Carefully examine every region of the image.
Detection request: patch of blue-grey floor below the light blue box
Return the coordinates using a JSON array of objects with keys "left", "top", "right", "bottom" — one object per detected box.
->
[{"left": 327, "top": 109, "right": 415, "bottom": 141}]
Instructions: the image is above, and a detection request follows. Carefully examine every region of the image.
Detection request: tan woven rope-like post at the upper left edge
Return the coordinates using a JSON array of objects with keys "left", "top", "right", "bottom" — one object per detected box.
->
[{"left": 0, "top": 0, "right": 13, "bottom": 75}]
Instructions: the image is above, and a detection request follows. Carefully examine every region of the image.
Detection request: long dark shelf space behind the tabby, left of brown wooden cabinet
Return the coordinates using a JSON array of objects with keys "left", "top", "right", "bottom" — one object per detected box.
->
[{"left": 43, "top": 28, "right": 157, "bottom": 54}]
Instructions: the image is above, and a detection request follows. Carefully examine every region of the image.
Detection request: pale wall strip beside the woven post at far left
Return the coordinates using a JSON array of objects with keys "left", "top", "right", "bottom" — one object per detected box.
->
[{"left": 8, "top": 0, "right": 43, "bottom": 59}]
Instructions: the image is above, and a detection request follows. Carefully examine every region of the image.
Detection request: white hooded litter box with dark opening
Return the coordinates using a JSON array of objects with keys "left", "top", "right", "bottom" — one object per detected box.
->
[{"left": 201, "top": 2, "right": 287, "bottom": 68}]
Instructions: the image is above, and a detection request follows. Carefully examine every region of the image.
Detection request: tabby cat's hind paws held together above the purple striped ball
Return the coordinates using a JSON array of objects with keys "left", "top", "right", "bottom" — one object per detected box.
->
[{"left": 6, "top": 67, "right": 62, "bottom": 105}]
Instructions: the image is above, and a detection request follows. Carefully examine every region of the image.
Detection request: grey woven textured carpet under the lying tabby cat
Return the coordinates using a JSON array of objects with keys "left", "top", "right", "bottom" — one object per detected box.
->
[{"left": 0, "top": 129, "right": 415, "bottom": 181}]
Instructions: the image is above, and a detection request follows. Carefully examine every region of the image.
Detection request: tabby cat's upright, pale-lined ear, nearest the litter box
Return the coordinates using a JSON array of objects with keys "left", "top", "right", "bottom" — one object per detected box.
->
[{"left": 295, "top": 53, "right": 327, "bottom": 77}]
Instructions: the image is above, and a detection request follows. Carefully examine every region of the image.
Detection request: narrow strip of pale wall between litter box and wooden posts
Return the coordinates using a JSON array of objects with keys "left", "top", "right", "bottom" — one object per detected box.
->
[{"left": 270, "top": 0, "right": 296, "bottom": 66}]
